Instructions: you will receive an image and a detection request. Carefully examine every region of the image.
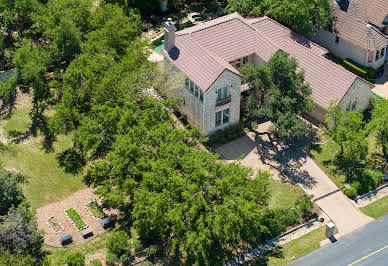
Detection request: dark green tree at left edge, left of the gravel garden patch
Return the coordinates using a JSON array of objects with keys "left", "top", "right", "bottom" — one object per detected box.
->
[{"left": 0, "top": 170, "right": 25, "bottom": 216}]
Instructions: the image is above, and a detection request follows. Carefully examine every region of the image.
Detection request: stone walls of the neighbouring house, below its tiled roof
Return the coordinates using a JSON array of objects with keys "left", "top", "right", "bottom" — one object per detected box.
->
[{"left": 312, "top": 30, "right": 388, "bottom": 69}]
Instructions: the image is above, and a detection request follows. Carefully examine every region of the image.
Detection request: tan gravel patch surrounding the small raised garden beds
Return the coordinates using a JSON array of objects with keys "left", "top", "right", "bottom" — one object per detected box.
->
[{"left": 36, "top": 188, "right": 117, "bottom": 247}]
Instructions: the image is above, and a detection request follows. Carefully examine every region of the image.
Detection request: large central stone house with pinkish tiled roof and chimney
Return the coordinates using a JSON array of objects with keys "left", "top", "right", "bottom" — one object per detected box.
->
[{"left": 162, "top": 13, "right": 372, "bottom": 135}]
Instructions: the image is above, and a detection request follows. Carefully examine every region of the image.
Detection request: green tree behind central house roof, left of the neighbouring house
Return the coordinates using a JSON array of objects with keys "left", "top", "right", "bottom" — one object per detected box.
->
[{"left": 226, "top": 0, "right": 331, "bottom": 36}]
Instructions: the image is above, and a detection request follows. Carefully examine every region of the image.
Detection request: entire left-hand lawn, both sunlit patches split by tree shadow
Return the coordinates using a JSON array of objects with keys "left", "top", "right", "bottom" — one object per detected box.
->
[{"left": 0, "top": 98, "right": 86, "bottom": 208}]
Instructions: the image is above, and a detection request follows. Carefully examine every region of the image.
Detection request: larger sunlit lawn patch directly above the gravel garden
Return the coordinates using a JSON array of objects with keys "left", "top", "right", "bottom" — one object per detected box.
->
[{"left": 2, "top": 136, "right": 86, "bottom": 208}]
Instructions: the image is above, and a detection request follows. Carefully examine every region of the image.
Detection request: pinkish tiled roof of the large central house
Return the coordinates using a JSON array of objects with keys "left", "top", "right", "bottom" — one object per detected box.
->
[{"left": 162, "top": 13, "right": 372, "bottom": 109}]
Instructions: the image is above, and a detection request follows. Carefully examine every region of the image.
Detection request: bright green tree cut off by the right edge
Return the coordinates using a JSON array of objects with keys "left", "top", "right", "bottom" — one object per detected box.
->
[{"left": 368, "top": 99, "right": 388, "bottom": 161}]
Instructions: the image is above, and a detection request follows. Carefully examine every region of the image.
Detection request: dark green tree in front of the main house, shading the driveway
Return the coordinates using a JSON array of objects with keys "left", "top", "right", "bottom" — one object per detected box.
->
[{"left": 252, "top": 51, "right": 314, "bottom": 138}]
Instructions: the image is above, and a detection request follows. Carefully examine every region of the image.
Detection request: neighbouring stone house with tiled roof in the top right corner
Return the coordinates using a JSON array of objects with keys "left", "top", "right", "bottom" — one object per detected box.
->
[{"left": 312, "top": 0, "right": 388, "bottom": 69}]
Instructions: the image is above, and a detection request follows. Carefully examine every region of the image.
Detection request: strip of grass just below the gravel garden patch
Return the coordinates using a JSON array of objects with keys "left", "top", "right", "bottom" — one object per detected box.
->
[{"left": 44, "top": 231, "right": 112, "bottom": 265}]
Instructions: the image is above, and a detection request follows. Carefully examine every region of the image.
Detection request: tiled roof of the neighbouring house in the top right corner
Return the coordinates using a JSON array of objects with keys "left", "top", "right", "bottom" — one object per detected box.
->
[{"left": 332, "top": 0, "right": 388, "bottom": 50}]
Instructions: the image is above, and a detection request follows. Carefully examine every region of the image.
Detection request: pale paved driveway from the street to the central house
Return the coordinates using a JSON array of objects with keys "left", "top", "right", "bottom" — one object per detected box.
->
[{"left": 216, "top": 122, "right": 373, "bottom": 236}]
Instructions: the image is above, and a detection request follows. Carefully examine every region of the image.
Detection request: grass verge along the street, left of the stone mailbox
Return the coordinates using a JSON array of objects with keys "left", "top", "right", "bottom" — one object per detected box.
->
[{"left": 256, "top": 226, "right": 326, "bottom": 266}]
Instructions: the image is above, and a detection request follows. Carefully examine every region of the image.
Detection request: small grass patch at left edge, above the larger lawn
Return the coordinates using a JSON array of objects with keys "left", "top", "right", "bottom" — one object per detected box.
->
[{"left": 3, "top": 106, "right": 31, "bottom": 136}]
